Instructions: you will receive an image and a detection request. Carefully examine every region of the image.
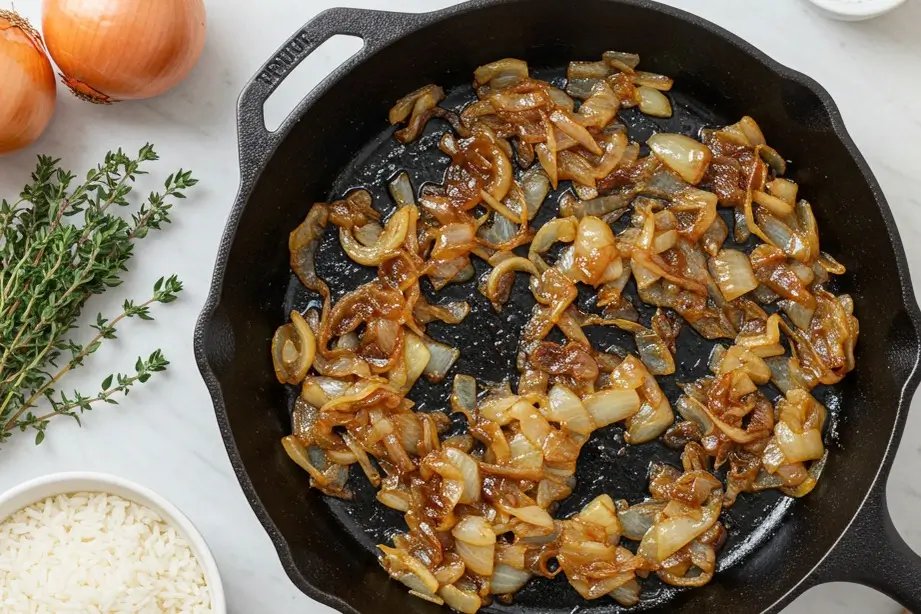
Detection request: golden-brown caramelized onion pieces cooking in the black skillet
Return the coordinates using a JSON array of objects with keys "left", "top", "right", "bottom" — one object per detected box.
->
[{"left": 273, "top": 51, "right": 859, "bottom": 613}]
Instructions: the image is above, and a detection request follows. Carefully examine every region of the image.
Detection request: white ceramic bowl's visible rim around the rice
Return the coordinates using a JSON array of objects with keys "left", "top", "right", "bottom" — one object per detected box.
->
[{"left": 0, "top": 472, "right": 227, "bottom": 614}]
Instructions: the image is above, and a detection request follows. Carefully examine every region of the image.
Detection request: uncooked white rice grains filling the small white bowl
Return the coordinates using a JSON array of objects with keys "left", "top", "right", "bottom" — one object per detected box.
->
[{"left": 0, "top": 492, "right": 211, "bottom": 614}]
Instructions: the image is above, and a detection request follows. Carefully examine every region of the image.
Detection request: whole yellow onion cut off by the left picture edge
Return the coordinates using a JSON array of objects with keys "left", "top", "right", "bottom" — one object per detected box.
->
[{"left": 0, "top": 10, "right": 57, "bottom": 155}]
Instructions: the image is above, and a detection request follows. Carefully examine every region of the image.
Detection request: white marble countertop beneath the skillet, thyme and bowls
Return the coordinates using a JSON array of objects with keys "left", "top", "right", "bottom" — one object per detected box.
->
[{"left": 0, "top": 0, "right": 921, "bottom": 614}]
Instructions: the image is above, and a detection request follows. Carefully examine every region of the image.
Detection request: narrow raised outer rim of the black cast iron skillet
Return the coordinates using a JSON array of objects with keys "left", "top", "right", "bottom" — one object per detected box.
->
[{"left": 194, "top": 0, "right": 921, "bottom": 614}]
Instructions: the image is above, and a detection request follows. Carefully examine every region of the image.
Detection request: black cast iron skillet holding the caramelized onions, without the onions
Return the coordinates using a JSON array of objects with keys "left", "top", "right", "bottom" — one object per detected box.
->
[{"left": 195, "top": 0, "right": 921, "bottom": 613}]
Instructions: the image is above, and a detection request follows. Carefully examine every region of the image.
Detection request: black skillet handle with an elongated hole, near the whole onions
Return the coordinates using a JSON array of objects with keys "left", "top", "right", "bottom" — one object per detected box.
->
[{"left": 237, "top": 8, "right": 427, "bottom": 176}]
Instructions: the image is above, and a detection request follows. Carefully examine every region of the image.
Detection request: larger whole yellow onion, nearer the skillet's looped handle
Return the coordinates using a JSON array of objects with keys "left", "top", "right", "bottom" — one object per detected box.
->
[{"left": 42, "top": 0, "right": 205, "bottom": 103}]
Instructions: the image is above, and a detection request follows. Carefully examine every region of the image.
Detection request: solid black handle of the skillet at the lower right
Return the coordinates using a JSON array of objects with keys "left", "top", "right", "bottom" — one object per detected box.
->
[{"left": 816, "top": 488, "right": 921, "bottom": 614}]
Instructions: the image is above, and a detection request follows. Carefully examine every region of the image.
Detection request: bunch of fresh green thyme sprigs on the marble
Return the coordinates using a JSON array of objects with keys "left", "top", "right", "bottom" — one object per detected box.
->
[{"left": 0, "top": 144, "right": 197, "bottom": 443}]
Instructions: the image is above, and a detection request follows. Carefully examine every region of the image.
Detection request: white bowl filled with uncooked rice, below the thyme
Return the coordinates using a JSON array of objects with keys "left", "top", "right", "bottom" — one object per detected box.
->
[{"left": 0, "top": 473, "right": 227, "bottom": 614}]
